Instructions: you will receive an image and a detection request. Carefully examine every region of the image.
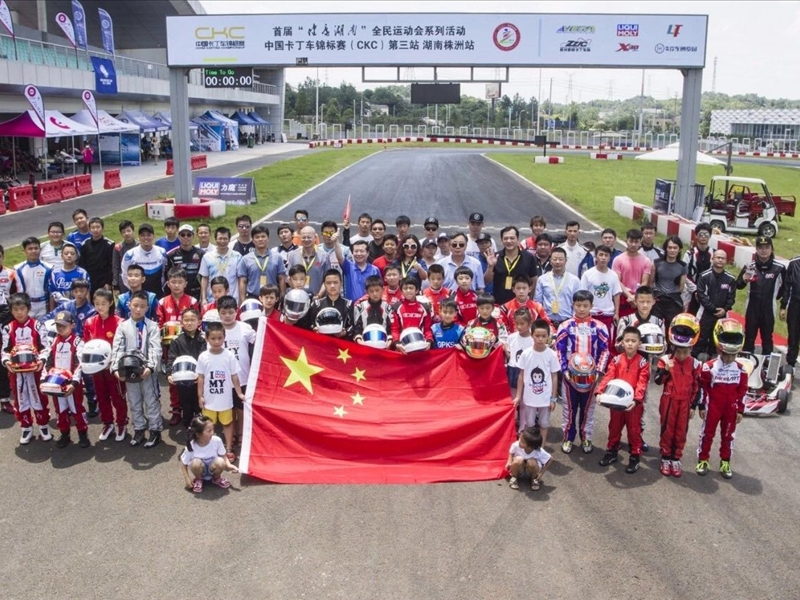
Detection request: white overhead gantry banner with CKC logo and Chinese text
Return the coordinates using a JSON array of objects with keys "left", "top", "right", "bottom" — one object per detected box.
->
[{"left": 167, "top": 13, "right": 708, "bottom": 68}]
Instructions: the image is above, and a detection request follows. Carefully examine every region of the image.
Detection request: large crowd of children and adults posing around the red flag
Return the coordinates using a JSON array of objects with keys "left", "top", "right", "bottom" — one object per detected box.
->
[{"left": 0, "top": 209, "right": 800, "bottom": 491}]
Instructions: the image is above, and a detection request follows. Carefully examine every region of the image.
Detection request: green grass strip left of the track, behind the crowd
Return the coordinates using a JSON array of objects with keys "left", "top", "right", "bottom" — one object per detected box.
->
[{"left": 4, "top": 146, "right": 383, "bottom": 265}]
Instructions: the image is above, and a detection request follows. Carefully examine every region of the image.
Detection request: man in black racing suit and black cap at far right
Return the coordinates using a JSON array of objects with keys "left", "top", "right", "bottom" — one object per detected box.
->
[{"left": 736, "top": 237, "right": 786, "bottom": 355}]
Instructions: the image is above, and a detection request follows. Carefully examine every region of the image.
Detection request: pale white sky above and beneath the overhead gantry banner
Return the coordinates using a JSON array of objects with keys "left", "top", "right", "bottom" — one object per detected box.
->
[{"left": 201, "top": 0, "right": 800, "bottom": 102}]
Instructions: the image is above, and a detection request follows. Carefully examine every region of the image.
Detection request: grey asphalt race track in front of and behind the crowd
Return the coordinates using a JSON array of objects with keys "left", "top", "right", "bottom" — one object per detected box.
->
[{"left": 0, "top": 146, "right": 800, "bottom": 599}]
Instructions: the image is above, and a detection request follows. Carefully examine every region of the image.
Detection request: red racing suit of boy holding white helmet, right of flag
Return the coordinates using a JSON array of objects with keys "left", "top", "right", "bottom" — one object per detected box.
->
[{"left": 596, "top": 353, "right": 650, "bottom": 456}]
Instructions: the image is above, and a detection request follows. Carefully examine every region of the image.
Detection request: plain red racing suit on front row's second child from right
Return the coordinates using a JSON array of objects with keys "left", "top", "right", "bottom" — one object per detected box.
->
[{"left": 653, "top": 354, "right": 703, "bottom": 460}]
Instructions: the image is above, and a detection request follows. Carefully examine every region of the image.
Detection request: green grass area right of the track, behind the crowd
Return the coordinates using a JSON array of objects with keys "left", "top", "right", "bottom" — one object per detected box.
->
[{"left": 488, "top": 152, "right": 800, "bottom": 336}]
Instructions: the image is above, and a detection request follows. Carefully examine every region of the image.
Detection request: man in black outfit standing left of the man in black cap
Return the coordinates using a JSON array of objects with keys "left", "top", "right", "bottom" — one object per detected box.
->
[{"left": 692, "top": 250, "right": 736, "bottom": 357}]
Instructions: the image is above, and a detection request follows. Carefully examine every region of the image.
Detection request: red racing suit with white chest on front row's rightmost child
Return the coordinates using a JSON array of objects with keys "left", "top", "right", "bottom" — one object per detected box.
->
[{"left": 697, "top": 358, "right": 747, "bottom": 460}]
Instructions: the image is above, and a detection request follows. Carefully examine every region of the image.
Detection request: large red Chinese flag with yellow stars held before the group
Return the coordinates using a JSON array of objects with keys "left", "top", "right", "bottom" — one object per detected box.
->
[{"left": 239, "top": 319, "right": 514, "bottom": 484}]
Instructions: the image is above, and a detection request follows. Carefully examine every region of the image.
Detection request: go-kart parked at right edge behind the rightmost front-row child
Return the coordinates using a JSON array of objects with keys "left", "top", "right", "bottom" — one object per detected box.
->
[{"left": 736, "top": 352, "right": 792, "bottom": 415}]
